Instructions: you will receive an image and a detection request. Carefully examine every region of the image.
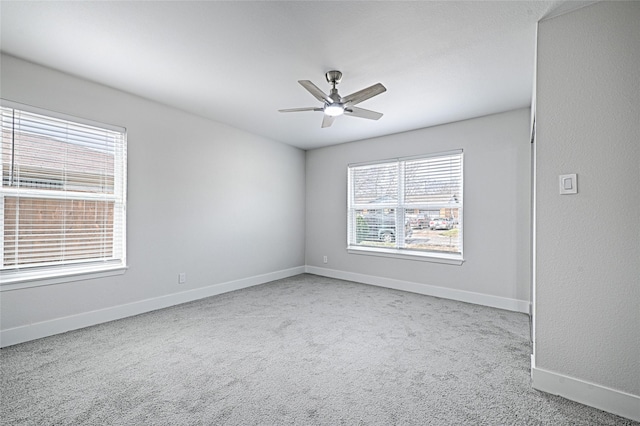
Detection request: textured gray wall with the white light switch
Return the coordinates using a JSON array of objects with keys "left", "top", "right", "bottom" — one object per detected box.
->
[{"left": 535, "top": 2, "right": 640, "bottom": 395}]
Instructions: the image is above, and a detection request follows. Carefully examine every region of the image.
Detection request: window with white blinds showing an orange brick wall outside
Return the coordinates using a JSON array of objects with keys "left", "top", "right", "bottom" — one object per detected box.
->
[{"left": 0, "top": 100, "right": 126, "bottom": 288}]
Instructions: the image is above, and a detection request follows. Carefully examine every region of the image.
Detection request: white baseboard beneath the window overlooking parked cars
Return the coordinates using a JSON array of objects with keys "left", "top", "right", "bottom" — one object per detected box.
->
[{"left": 305, "top": 265, "right": 529, "bottom": 314}]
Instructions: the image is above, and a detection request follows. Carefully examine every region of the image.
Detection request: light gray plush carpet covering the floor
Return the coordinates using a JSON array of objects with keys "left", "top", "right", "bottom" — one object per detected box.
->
[{"left": 0, "top": 275, "right": 637, "bottom": 425}]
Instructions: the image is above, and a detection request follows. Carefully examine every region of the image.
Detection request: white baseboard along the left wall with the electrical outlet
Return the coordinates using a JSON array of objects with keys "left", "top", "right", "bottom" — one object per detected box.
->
[{"left": 0, "top": 266, "right": 305, "bottom": 347}]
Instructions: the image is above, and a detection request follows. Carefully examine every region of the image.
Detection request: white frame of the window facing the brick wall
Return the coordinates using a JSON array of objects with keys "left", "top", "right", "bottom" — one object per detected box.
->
[{"left": 0, "top": 99, "right": 127, "bottom": 291}]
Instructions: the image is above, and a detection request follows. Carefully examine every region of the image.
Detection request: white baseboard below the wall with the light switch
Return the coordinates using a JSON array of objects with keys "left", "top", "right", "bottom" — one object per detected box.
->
[{"left": 531, "top": 366, "right": 640, "bottom": 421}]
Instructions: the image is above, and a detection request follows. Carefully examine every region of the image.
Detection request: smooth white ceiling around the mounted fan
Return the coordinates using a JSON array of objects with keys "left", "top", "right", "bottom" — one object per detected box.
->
[{"left": 0, "top": 0, "right": 588, "bottom": 149}]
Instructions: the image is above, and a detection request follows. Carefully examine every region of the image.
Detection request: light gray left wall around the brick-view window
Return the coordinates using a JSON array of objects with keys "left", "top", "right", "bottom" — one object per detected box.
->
[{"left": 1, "top": 55, "right": 305, "bottom": 330}]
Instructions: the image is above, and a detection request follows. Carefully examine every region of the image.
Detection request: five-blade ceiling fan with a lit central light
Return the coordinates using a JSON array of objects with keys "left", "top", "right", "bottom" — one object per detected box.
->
[{"left": 279, "top": 70, "right": 387, "bottom": 127}]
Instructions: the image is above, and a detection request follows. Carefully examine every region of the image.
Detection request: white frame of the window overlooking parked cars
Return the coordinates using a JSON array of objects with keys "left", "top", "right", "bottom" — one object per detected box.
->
[{"left": 347, "top": 149, "right": 464, "bottom": 265}]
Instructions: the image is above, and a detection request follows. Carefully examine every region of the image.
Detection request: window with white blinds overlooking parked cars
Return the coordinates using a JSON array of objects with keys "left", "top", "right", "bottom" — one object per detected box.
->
[{"left": 348, "top": 150, "right": 463, "bottom": 264}]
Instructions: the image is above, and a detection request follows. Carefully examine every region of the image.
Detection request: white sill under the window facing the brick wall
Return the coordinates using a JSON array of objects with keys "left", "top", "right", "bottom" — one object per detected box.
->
[{"left": 0, "top": 265, "right": 128, "bottom": 292}]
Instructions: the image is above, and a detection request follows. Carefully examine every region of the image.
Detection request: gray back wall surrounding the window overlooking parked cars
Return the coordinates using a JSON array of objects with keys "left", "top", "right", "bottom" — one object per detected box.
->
[{"left": 306, "top": 108, "right": 531, "bottom": 309}]
